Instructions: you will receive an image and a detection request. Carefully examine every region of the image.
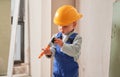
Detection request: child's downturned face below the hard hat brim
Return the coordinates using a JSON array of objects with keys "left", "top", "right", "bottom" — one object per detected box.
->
[{"left": 58, "top": 22, "right": 76, "bottom": 34}]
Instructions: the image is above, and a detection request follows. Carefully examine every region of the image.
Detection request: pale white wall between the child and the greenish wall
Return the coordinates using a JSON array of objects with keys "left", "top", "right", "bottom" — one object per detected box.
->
[{"left": 80, "top": 0, "right": 113, "bottom": 77}]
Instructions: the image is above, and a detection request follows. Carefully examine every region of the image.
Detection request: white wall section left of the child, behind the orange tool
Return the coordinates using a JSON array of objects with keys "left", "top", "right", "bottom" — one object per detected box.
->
[{"left": 29, "top": 0, "right": 51, "bottom": 77}]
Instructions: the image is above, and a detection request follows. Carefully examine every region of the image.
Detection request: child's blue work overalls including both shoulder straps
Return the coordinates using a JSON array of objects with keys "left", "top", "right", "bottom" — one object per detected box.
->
[{"left": 53, "top": 33, "right": 79, "bottom": 77}]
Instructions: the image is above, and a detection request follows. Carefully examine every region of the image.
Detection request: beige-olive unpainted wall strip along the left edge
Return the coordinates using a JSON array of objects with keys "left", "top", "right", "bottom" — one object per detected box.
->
[{"left": 0, "top": 0, "right": 11, "bottom": 76}]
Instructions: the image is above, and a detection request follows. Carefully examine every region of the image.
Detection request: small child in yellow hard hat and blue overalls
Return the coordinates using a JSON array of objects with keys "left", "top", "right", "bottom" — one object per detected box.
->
[{"left": 42, "top": 5, "right": 82, "bottom": 77}]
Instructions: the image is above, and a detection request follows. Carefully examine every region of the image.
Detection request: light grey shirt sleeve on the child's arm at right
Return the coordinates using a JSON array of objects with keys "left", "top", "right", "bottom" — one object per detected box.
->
[{"left": 61, "top": 35, "right": 82, "bottom": 57}]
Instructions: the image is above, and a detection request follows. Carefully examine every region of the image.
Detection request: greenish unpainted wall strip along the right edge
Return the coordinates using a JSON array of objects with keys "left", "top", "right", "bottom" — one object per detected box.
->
[{"left": 109, "top": 1, "right": 120, "bottom": 77}]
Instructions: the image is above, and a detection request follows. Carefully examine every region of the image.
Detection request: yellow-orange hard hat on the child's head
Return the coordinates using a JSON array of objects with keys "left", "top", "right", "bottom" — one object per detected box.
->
[{"left": 53, "top": 5, "right": 82, "bottom": 26}]
